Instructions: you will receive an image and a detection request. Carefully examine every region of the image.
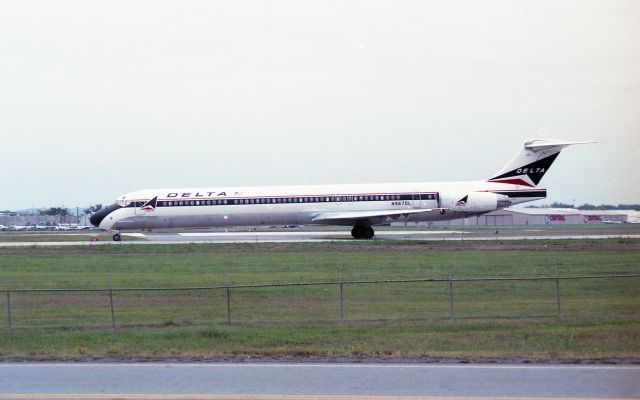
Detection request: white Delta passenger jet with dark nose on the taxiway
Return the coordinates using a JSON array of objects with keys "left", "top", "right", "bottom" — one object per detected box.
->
[{"left": 90, "top": 139, "right": 595, "bottom": 241}]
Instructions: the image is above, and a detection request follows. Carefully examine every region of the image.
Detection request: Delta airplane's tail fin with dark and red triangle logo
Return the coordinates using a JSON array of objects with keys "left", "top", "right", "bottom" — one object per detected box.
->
[{"left": 488, "top": 139, "right": 596, "bottom": 187}]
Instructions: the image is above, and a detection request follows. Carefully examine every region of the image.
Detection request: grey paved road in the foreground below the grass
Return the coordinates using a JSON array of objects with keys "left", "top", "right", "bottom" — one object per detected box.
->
[{"left": 0, "top": 363, "right": 640, "bottom": 399}]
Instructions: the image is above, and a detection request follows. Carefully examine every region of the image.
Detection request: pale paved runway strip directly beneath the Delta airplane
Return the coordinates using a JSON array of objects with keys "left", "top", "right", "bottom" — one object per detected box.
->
[{"left": 0, "top": 229, "right": 640, "bottom": 247}]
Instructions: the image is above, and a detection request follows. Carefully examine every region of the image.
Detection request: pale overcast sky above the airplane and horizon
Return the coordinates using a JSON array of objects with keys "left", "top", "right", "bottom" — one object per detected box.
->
[{"left": 0, "top": 0, "right": 640, "bottom": 209}]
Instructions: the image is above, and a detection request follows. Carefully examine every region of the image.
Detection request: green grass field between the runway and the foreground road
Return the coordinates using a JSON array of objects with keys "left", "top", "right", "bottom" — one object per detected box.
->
[{"left": 0, "top": 239, "right": 640, "bottom": 359}]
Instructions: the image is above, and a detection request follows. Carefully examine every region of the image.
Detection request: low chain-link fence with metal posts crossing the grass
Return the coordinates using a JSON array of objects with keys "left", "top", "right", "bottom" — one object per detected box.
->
[{"left": 0, "top": 274, "right": 640, "bottom": 331}]
